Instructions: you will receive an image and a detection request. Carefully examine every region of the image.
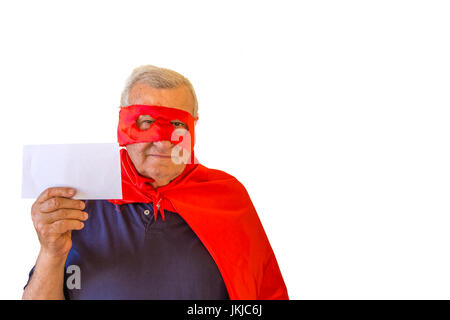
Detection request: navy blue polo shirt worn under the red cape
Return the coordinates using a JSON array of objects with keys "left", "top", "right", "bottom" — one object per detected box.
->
[{"left": 24, "top": 200, "right": 229, "bottom": 300}]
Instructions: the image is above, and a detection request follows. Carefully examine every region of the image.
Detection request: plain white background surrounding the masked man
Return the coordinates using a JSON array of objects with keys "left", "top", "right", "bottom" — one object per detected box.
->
[{"left": 0, "top": 0, "right": 450, "bottom": 299}]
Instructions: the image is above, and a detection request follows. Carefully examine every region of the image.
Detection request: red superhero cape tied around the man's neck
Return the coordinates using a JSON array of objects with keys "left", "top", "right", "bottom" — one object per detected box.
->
[{"left": 108, "top": 149, "right": 289, "bottom": 300}]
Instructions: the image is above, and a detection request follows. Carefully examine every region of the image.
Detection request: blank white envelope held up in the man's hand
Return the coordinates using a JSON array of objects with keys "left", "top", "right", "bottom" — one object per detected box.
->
[{"left": 22, "top": 143, "right": 122, "bottom": 199}]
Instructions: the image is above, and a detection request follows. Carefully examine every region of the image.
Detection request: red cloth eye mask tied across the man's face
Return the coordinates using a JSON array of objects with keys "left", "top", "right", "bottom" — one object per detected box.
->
[{"left": 117, "top": 105, "right": 198, "bottom": 163}]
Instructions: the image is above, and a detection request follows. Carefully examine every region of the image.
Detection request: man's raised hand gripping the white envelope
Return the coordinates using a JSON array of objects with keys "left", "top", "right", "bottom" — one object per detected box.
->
[{"left": 31, "top": 187, "right": 88, "bottom": 259}]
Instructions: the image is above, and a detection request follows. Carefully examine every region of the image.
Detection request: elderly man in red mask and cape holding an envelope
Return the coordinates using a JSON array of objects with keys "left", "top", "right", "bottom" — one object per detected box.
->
[{"left": 23, "top": 66, "right": 288, "bottom": 300}]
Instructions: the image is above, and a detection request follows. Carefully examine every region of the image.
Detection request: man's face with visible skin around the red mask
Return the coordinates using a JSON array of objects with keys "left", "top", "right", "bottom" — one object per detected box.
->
[{"left": 126, "top": 83, "right": 194, "bottom": 185}]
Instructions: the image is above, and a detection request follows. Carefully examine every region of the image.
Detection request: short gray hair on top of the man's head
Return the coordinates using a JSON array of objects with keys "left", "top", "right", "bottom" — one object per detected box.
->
[{"left": 120, "top": 65, "right": 198, "bottom": 118}]
